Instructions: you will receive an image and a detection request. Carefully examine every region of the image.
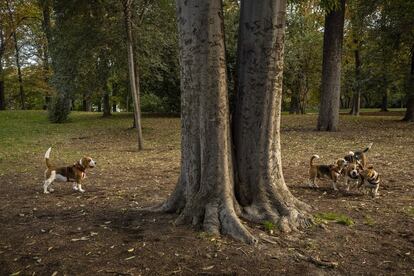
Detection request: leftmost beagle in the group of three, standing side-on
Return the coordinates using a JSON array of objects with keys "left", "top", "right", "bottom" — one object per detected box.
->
[{"left": 309, "top": 154, "right": 348, "bottom": 191}]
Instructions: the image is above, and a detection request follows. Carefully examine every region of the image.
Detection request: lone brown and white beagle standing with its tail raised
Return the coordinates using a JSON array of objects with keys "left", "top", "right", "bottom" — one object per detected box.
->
[{"left": 43, "top": 148, "right": 96, "bottom": 194}]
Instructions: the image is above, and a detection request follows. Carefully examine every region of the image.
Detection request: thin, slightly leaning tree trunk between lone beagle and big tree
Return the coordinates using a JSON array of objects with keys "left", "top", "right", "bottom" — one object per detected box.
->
[{"left": 123, "top": 0, "right": 144, "bottom": 150}]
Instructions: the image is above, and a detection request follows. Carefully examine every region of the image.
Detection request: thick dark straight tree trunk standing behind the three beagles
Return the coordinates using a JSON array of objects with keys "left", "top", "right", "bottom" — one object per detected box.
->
[{"left": 317, "top": 0, "right": 345, "bottom": 131}]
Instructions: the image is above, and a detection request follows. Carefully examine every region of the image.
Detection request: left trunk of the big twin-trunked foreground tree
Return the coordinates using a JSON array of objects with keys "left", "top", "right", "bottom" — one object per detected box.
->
[{"left": 152, "top": 0, "right": 255, "bottom": 243}]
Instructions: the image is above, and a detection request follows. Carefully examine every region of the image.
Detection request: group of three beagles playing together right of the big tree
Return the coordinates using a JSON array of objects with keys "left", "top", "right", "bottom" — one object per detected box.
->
[{"left": 309, "top": 143, "right": 381, "bottom": 198}]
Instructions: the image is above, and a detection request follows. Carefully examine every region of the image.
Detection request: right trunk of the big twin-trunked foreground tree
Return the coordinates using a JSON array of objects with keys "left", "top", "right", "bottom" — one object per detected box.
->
[{"left": 233, "top": 0, "right": 306, "bottom": 231}]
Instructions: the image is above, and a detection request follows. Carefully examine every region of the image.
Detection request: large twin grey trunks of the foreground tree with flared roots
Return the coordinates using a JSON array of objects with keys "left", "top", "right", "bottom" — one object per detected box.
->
[{"left": 153, "top": 0, "right": 309, "bottom": 243}]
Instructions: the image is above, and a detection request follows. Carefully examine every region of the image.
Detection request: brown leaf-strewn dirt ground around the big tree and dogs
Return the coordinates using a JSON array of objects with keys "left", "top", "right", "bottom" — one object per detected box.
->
[{"left": 0, "top": 111, "right": 414, "bottom": 275}]
